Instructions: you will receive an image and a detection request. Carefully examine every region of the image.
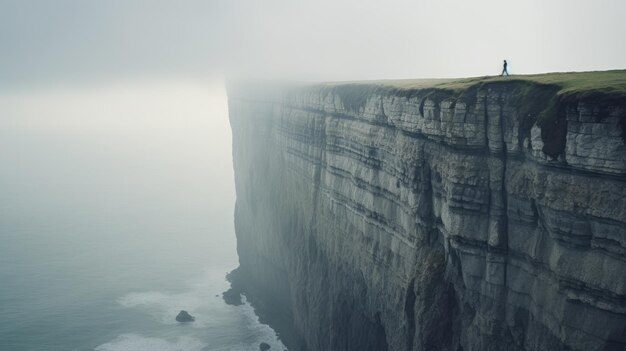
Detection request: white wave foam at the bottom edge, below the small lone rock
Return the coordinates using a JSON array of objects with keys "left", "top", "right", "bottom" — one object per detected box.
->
[{"left": 95, "top": 334, "right": 206, "bottom": 351}]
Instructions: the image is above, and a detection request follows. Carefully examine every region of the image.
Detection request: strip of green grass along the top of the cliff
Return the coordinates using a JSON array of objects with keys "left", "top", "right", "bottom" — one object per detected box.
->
[{"left": 320, "top": 70, "right": 626, "bottom": 97}]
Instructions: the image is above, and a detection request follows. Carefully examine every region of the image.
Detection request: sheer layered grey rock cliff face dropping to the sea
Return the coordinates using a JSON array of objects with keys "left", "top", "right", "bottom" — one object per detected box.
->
[{"left": 229, "top": 77, "right": 626, "bottom": 351}]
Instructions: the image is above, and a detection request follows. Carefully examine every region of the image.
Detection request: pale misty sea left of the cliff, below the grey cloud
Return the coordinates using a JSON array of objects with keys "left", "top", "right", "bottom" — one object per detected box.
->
[{"left": 0, "top": 81, "right": 282, "bottom": 351}]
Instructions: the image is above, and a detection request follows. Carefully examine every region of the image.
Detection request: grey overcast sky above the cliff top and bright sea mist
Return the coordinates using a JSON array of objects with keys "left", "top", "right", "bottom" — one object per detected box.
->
[{"left": 0, "top": 0, "right": 626, "bottom": 89}]
